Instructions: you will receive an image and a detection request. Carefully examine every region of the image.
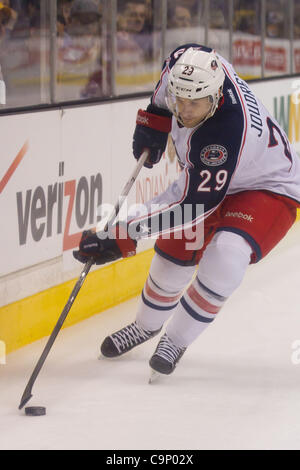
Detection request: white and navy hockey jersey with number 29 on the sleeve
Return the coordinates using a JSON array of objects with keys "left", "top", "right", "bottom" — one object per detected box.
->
[{"left": 130, "top": 44, "right": 300, "bottom": 237}]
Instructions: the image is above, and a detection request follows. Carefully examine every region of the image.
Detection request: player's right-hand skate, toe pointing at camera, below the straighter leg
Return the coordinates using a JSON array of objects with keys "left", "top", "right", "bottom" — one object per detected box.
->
[{"left": 149, "top": 334, "right": 186, "bottom": 383}]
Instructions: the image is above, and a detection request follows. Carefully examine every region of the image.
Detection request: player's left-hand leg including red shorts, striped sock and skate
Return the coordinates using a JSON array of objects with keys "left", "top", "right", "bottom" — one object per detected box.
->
[{"left": 101, "top": 207, "right": 216, "bottom": 357}]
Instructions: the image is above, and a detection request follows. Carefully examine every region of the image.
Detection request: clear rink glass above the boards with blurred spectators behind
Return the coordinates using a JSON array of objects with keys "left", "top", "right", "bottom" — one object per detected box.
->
[{"left": 0, "top": 0, "right": 300, "bottom": 112}]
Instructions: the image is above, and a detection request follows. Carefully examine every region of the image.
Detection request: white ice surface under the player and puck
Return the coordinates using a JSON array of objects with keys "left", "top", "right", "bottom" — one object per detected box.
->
[{"left": 0, "top": 223, "right": 300, "bottom": 450}]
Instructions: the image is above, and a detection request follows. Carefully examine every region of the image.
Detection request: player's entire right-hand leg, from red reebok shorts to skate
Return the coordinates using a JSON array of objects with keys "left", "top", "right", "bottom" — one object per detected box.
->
[{"left": 150, "top": 191, "right": 296, "bottom": 373}]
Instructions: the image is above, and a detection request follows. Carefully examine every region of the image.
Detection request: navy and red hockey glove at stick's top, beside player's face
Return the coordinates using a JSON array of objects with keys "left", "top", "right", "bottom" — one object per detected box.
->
[{"left": 132, "top": 104, "right": 172, "bottom": 168}]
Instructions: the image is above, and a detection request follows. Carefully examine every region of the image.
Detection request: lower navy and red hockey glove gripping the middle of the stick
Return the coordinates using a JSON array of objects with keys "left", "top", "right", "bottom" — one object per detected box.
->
[{"left": 73, "top": 224, "right": 137, "bottom": 264}]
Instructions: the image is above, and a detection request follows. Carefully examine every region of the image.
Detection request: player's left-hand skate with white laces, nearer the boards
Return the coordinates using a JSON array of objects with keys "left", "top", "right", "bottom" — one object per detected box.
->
[{"left": 101, "top": 322, "right": 161, "bottom": 357}]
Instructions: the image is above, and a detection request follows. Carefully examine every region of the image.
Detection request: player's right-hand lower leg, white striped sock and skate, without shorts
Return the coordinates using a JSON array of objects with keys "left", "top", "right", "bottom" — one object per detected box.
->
[{"left": 150, "top": 231, "right": 252, "bottom": 374}]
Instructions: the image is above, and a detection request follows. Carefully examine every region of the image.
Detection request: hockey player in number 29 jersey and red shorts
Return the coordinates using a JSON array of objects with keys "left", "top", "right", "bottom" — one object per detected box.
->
[{"left": 74, "top": 44, "right": 300, "bottom": 374}]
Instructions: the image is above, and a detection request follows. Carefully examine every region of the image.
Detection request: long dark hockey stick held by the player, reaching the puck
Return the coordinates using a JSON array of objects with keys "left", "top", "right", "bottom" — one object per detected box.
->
[{"left": 19, "top": 150, "right": 149, "bottom": 410}]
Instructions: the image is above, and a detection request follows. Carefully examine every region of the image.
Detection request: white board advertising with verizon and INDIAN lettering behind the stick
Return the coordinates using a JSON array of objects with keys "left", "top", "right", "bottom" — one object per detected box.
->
[{"left": 0, "top": 102, "right": 179, "bottom": 276}]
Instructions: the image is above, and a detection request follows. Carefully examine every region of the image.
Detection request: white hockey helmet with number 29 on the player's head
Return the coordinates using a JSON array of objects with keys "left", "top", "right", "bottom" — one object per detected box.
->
[{"left": 166, "top": 47, "right": 225, "bottom": 124}]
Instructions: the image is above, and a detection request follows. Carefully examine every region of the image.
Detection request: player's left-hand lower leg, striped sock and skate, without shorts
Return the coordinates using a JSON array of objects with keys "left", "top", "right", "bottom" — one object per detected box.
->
[{"left": 101, "top": 254, "right": 195, "bottom": 357}]
